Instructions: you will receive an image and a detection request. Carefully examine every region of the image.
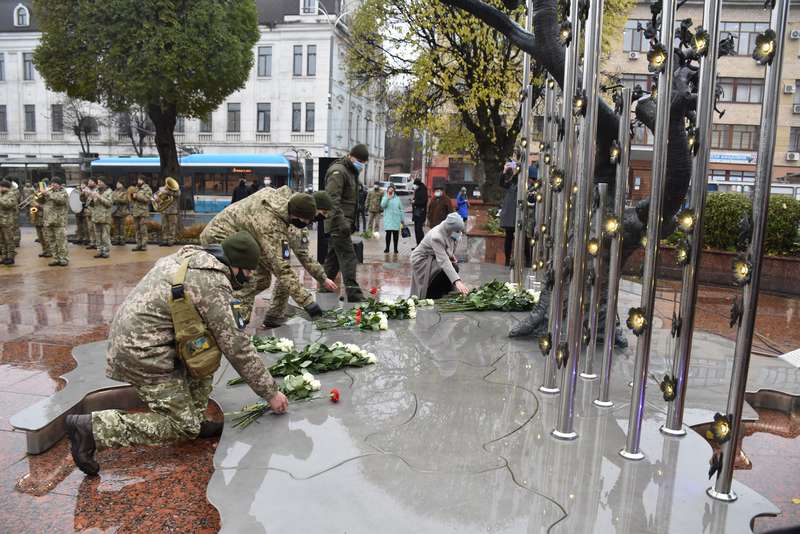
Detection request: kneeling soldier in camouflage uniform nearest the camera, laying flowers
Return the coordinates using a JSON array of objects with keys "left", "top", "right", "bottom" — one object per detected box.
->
[{"left": 66, "top": 232, "right": 288, "bottom": 475}]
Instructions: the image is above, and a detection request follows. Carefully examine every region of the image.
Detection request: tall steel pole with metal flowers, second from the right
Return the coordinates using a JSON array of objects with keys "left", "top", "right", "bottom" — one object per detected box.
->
[{"left": 661, "top": 0, "right": 722, "bottom": 436}]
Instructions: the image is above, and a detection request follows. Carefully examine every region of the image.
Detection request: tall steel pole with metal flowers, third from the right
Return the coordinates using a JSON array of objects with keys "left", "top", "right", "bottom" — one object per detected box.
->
[{"left": 620, "top": 0, "right": 677, "bottom": 460}]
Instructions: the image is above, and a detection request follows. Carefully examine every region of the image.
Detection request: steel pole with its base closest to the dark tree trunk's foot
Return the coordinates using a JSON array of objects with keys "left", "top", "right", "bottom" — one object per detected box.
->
[{"left": 539, "top": 1, "right": 582, "bottom": 393}]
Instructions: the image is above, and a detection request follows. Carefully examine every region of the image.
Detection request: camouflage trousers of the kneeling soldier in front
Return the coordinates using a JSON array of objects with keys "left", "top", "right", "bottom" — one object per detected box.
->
[{"left": 92, "top": 376, "right": 213, "bottom": 448}]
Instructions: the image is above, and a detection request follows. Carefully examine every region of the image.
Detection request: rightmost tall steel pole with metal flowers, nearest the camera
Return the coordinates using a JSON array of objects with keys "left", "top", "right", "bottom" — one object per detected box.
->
[{"left": 708, "top": 0, "right": 789, "bottom": 501}]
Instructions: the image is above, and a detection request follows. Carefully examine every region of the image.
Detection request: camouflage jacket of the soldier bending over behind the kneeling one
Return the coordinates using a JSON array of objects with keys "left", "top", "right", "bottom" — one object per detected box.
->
[{"left": 200, "top": 186, "right": 314, "bottom": 306}]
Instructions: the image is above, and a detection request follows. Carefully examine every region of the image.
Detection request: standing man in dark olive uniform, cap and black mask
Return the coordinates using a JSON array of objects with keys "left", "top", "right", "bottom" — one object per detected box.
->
[{"left": 325, "top": 145, "right": 369, "bottom": 302}]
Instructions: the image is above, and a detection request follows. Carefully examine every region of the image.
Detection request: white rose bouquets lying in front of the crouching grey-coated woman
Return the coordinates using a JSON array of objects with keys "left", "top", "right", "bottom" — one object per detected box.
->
[{"left": 438, "top": 280, "right": 539, "bottom": 312}]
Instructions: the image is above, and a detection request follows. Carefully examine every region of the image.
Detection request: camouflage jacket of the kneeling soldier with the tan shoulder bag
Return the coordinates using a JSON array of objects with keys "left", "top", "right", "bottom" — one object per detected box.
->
[{"left": 106, "top": 245, "right": 277, "bottom": 399}]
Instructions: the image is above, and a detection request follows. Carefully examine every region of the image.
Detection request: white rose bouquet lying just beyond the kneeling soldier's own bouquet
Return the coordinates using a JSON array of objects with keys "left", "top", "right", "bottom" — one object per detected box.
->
[{"left": 228, "top": 337, "right": 378, "bottom": 386}]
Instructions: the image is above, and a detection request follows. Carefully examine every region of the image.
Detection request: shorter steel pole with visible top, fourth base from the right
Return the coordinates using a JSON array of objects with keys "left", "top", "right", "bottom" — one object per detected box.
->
[{"left": 594, "top": 88, "right": 632, "bottom": 408}]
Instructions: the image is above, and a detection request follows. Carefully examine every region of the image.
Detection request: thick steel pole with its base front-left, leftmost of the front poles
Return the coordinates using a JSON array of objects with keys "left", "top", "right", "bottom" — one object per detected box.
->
[{"left": 552, "top": 0, "right": 603, "bottom": 439}]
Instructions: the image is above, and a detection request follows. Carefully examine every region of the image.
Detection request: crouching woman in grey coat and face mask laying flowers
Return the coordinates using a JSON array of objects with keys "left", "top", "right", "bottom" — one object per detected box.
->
[{"left": 411, "top": 213, "right": 469, "bottom": 299}]
